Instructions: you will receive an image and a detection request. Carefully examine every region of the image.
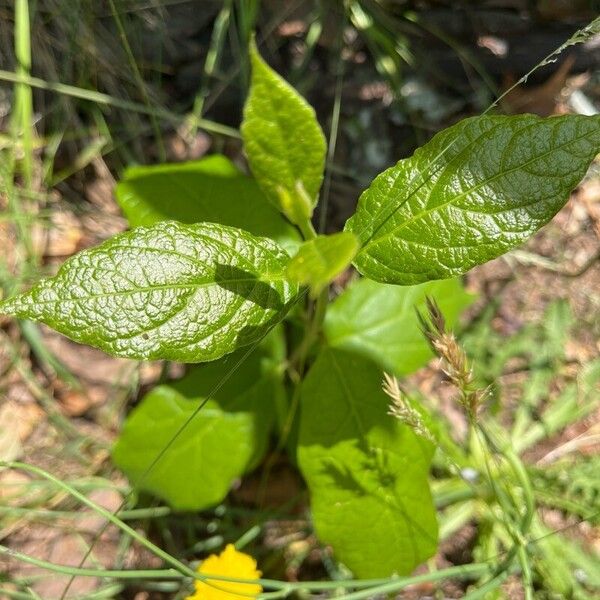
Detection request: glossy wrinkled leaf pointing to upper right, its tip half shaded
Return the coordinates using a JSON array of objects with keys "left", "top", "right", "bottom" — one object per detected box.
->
[{"left": 346, "top": 115, "right": 600, "bottom": 285}]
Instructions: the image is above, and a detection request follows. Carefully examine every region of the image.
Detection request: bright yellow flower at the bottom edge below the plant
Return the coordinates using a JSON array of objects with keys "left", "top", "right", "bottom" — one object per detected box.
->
[{"left": 186, "top": 544, "right": 262, "bottom": 600}]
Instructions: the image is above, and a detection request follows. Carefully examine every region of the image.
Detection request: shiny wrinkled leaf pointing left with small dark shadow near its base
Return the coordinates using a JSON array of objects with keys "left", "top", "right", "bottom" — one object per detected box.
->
[{"left": 0, "top": 221, "right": 298, "bottom": 362}]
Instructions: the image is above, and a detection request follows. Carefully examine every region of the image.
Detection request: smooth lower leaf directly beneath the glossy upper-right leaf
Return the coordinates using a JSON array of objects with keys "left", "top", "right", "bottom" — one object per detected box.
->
[{"left": 325, "top": 279, "right": 473, "bottom": 375}]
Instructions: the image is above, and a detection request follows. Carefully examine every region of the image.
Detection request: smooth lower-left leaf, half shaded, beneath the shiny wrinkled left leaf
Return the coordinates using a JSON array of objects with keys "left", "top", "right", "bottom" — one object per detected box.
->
[{"left": 113, "top": 336, "right": 285, "bottom": 510}]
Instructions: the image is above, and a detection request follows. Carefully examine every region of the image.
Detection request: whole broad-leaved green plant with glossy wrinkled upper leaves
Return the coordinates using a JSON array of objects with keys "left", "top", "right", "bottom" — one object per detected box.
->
[{"left": 0, "top": 36, "right": 600, "bottom": 578}]
